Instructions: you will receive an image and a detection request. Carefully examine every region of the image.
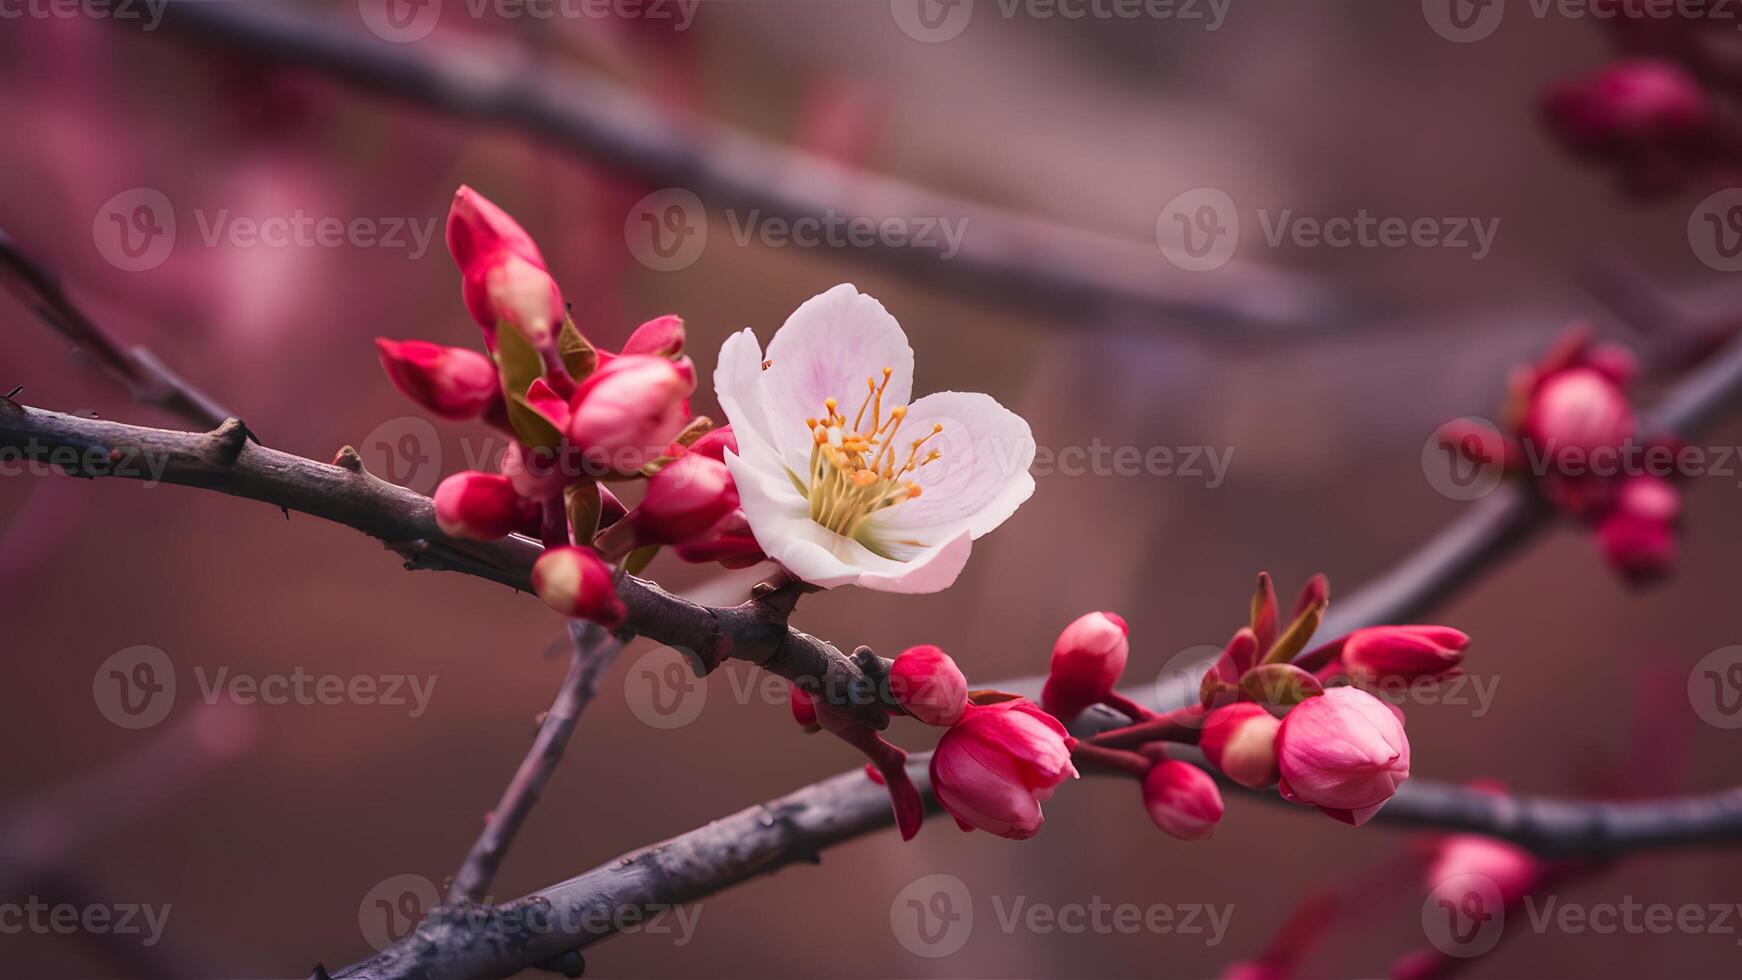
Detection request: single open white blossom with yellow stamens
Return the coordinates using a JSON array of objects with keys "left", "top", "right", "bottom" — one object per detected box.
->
[{"left": 714, "top": 284, "right": 1035, "bottom": 592}]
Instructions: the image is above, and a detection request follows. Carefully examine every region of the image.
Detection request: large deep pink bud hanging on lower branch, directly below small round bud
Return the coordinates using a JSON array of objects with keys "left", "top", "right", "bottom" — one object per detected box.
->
[{"left": 932, "top": 698, "right": 1077, "bottom": 841}]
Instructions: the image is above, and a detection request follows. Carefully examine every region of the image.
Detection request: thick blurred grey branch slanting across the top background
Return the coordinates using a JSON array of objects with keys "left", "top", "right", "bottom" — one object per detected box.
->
[{"left": 142, "top": 0, "right": 1340, "bottom": 339}]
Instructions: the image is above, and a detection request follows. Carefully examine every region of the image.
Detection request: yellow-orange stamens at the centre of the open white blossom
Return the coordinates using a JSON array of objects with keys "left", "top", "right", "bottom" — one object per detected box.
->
[{"left": 793, "top": 367, "right": 944, "bottom": 550}]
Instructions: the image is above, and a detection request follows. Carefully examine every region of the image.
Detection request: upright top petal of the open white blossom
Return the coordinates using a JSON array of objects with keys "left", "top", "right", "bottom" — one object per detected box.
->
[{"left": 761, "top": 284, "right": 913, "bottom": 470}]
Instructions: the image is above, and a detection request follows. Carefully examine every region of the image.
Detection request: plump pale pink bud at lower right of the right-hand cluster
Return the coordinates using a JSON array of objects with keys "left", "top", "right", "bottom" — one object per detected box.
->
[{"left": 1277, "top": 688, "right": 1409, "bottom": 827}]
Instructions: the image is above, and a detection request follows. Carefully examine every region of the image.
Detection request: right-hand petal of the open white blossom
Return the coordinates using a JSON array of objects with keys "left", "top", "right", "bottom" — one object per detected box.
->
[{"left": 873, "top": 392, "right": 1035, "bottom": 555}]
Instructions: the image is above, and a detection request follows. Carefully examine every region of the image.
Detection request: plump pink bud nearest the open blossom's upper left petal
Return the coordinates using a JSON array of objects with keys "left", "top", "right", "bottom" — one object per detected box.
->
[{"left": 568, "top": 355, "right": 695, "bottom": 475}]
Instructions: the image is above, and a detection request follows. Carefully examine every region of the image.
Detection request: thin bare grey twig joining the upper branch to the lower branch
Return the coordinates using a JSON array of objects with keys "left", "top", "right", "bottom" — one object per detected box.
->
[{"left": 448, "top": 623, "right": 624, "bottom": 902}]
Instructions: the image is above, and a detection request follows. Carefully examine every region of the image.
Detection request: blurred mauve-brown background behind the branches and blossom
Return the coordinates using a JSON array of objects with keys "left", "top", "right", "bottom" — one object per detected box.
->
[{"left": 0, "top": 0, "right": 1742, "bottom": 978}]
